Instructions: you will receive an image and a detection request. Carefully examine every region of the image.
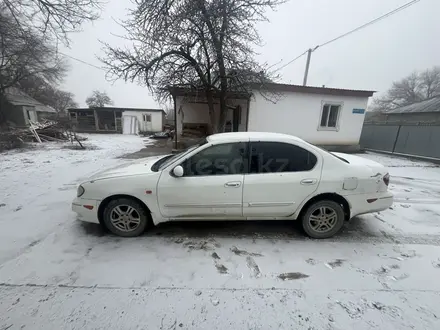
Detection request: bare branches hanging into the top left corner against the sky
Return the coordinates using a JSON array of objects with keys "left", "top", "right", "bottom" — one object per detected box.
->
[{"left": 0, "top": 0, "right": 101, "bottom": 43}]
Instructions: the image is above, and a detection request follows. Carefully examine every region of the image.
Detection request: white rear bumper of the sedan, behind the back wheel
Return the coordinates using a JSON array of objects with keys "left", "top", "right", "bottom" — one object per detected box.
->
[{"left": 346, "top": 191, "right": 394, "bottom": 217}]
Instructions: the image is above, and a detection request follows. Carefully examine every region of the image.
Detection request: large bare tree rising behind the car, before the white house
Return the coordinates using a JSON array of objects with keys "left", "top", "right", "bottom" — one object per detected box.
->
[{"left": 101, "top": 0, "right": 284, "bottom": 132}]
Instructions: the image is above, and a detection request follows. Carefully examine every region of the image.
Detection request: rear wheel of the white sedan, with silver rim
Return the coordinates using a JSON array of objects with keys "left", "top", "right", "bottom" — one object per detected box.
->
[{"left": 301, "top": 200, "right": 345, "bottom": 239}]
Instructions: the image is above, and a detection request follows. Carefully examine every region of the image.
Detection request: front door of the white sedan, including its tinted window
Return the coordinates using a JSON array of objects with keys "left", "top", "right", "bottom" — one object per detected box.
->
[{"left": 158, "top": 142, "right": 248, "bottom": 219}]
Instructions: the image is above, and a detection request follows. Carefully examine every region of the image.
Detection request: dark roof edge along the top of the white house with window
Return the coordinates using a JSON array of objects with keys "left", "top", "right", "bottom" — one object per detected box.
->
[{"left": 250, "top": 83, "right": 376, "bottom": 97}]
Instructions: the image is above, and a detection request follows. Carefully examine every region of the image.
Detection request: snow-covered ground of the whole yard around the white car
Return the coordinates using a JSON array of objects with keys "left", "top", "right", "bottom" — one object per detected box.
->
[{"left": 0, "top": 140, "right": 440, "bottom": 329}]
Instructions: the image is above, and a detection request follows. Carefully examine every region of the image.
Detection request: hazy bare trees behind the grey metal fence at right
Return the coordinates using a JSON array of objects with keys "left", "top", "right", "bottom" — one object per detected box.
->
[{"left": 373, "top": 66, "right": 440, "bottom": 111}]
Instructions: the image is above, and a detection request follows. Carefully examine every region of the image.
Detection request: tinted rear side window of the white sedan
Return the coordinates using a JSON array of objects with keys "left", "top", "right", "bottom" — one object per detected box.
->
[{"left": 249, "top": 142, "right": 318, "bottom": 173}]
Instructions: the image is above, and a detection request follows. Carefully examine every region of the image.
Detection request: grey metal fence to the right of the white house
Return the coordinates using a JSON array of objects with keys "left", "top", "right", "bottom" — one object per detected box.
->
[{"left": 360, "top": 123, "right": 440, "bottom": 158}]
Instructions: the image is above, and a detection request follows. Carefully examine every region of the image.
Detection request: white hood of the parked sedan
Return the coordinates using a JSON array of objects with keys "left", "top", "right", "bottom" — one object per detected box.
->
[{"left": 89, "top": 155, "right": 168, "bottom": 181}]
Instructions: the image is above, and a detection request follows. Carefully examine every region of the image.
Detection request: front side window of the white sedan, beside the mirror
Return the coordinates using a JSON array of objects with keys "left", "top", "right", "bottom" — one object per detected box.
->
[{"left": 181, "top": 142, "right": 247, "bottom": 176}]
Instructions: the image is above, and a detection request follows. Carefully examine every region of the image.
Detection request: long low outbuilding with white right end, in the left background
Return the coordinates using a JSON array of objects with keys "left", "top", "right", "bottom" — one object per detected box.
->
[{"left": 68, "top": 107, "right": 165, "bottom": 134}]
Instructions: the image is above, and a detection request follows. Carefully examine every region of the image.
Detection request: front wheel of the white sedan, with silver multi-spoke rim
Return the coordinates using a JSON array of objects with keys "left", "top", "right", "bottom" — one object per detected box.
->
[{"left": 103, "top": 198, "right": 151, "bottom": 237}]
